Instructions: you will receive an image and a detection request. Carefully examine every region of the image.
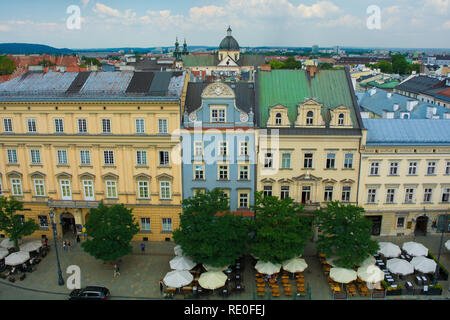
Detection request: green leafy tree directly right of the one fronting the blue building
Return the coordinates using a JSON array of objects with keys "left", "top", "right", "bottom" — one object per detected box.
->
[{"left": 251, "top": 192, "right": 313, "bottom": 263}]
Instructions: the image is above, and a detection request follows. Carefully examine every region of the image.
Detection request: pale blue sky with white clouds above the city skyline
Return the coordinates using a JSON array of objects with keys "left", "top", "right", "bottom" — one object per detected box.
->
[{"left": 0, "top": 0, "right": 450, "bottom": 49}]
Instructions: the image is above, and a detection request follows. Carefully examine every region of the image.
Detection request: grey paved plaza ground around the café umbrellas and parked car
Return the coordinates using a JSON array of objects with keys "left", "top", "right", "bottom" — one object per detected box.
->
[{"left": 0, "top": 235, "right": 450, "bottom": 300}]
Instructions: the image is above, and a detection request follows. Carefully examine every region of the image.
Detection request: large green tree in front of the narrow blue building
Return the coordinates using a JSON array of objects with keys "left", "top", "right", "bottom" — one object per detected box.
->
[{"left": 173, "top": 188, "right": 250, "bottom": 267}]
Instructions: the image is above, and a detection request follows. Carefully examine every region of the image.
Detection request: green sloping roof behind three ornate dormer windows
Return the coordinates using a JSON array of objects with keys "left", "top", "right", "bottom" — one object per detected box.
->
[{"left": 258, "top": 70, "right": 358, "bottom": 128}]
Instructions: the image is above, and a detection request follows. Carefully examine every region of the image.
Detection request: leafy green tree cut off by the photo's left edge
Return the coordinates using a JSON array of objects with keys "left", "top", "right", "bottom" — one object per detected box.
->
[{"left": 0, "top": 197, "right": 39, "bottom": 251}]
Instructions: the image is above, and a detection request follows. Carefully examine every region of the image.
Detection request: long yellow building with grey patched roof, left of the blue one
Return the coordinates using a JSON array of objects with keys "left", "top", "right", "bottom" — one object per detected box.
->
[{"left": 0, "top": 72, "right": 187, "bottom": 241}]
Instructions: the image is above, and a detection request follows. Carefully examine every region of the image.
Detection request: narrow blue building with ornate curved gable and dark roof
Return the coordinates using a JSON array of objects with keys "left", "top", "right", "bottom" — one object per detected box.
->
[{"left": 181, "top": 82, "right": 257, "bottom": 215}]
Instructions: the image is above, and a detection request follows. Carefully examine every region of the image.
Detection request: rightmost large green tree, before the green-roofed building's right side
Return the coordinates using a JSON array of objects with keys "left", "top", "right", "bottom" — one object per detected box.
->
[{"left": 316, "top": 201, "right": 379, "bottom": 268}]
